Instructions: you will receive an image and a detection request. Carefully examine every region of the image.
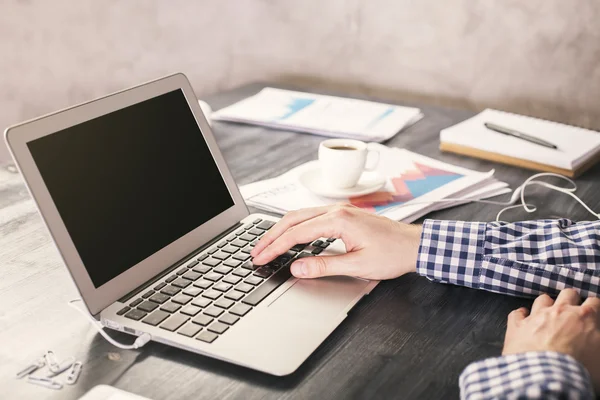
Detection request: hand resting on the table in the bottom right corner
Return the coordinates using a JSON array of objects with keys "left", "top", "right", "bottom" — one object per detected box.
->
[{"left": 502, "top": 289, "right": 600, "bottom": 389}]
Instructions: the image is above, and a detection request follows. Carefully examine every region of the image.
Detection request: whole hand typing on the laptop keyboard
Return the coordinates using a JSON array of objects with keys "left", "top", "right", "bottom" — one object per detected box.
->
[{"left": 251, "top": 205, "right": 421, "bottom": 280}]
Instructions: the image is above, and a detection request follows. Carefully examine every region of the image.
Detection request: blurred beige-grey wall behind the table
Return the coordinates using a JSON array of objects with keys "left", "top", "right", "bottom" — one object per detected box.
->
[{"left": 0, "top": 0, "right": 600, "bottom": 159}]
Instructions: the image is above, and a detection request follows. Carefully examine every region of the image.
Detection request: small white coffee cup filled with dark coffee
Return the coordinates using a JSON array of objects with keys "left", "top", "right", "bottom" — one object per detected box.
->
[{"left": 319, "top": 139, "right": 379, "bottom": 189}]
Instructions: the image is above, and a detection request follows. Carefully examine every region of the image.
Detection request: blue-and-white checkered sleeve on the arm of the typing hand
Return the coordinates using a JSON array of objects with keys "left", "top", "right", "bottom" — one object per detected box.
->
[{"left": 417, "top": 219, "right": 600, "bottom": 297}]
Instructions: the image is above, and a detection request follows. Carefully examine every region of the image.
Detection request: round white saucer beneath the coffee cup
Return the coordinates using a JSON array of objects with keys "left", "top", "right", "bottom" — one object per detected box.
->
[{"left": 298, "top": 166, "right": 385, "bottom": 199}]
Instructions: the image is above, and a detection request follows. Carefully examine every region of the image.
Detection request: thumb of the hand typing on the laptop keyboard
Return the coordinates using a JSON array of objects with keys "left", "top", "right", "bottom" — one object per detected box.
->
[{"left": 291, "top": 253, "right": 360, "bottom": 278}]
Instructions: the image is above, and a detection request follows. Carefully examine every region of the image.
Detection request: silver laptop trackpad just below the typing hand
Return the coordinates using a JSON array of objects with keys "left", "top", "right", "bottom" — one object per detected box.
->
[{"left": 269, "top": 276, "right": 370, "bottom": 318}]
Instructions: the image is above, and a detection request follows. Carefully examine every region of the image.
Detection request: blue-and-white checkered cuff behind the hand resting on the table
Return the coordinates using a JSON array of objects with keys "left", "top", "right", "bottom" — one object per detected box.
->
[{"left": 459, "top": 352, "right": 595, "bottom": 400}]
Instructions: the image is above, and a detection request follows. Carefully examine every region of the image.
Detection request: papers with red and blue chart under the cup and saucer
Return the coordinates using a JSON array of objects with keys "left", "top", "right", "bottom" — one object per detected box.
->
[{"left": 240, "top": 143, "right": 510, "bottom": 222}]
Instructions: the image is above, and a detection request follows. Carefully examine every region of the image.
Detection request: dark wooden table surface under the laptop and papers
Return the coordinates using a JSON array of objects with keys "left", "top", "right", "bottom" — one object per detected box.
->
[{"left": 0, "top": 84, "right": 600, "bottom": 400}]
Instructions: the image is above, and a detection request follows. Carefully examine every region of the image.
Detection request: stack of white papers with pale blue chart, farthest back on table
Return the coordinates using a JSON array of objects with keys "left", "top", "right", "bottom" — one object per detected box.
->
[{"left": 211, "top": 88, "right": 423, "bottom": 142}]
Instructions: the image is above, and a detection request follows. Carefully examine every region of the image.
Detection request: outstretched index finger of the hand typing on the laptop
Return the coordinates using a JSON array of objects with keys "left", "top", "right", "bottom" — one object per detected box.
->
[{"left": 252, "top": 213, "right": 343, "bottom": 265}]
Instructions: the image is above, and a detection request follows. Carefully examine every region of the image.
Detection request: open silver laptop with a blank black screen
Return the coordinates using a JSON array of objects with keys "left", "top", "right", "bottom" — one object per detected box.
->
[{"left": 5, "top": 74, "right": 377, "bottom": 375}]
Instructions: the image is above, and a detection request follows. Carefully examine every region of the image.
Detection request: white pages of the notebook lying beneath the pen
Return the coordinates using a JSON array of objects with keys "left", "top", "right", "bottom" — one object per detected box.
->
[{"left": 440, "top": 109, "right": 600, "bottom": 170}]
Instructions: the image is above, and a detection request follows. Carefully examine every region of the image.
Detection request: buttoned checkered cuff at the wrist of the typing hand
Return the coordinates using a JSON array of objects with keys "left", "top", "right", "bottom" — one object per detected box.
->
[{"left": 417, "top": 219, "right": 487, "bottom": 288}]
